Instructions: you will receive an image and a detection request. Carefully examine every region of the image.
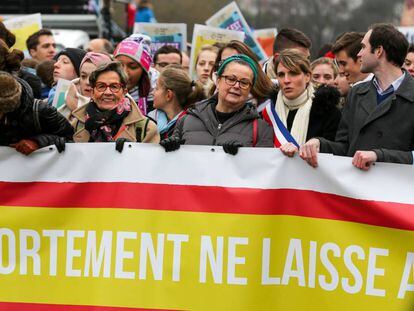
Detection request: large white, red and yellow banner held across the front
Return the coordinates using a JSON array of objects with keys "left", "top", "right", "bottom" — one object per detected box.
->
[{"left": 0, "top": 144, "right": 414, "bottom": 311}]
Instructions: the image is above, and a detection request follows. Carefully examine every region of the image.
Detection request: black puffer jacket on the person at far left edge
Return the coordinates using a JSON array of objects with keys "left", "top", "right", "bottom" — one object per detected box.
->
[{"left": 0, "top": 78, "right": 73, "bottom": 147}]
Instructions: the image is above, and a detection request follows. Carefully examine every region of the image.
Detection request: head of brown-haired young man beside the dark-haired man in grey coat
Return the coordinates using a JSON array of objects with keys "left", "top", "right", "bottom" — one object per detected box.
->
[{"left": 332, "top": 32, "right": 373, "bottom": 86}]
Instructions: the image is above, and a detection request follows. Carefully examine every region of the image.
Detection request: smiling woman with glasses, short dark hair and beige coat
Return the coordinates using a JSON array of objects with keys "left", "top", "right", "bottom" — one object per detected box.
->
[{"left": 72, "top": 62, "right": 160, "bottom": 152}]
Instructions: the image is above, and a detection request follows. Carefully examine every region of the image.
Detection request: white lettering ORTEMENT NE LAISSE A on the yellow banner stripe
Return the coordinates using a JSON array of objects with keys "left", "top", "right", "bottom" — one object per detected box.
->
[{"left": 0, "top": 228, "right": 414, "bottom": 299}]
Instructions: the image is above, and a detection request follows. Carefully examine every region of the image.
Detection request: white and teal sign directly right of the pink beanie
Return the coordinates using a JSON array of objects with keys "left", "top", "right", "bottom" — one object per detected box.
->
[{"left": 134, "top": 23, "right": 187, "bottom": 55}]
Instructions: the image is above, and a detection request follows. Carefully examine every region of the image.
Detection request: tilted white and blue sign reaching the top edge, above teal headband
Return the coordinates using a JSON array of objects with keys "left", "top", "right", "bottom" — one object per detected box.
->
[{"left": 206, "top": 1, "right": 267, "bottom": 61}]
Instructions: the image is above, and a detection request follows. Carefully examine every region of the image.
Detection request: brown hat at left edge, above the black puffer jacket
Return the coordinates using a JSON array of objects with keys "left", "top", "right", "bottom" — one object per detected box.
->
[{"left": 0, "top": 71, "right": 22, "bottom": 113}]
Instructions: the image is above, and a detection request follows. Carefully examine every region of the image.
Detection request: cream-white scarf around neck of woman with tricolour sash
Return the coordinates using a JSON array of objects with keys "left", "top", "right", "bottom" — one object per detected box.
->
[{"left": 275, "top": 83, "right": 314, "bottom": 145}]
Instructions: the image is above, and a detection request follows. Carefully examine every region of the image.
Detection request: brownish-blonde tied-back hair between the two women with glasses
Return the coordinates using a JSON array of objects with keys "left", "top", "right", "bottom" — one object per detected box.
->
[{"left": 158, "top": 65, "right": 205, "bottom": 109}]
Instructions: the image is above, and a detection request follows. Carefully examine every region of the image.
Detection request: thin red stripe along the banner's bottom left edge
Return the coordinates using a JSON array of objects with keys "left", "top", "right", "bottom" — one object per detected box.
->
[{"left": 0, "top": 302, "right": 178, "bottom": 311}]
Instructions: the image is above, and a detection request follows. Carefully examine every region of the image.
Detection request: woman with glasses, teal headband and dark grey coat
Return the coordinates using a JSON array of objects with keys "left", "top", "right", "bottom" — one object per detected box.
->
[{"left": 160, "top": 55, "right": 273, "bottom": 155}]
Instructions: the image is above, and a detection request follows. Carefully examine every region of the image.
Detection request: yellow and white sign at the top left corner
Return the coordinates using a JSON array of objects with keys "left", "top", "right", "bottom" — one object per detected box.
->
[{"left": 3, "top": 13, "right": 42, "bottom": 55}]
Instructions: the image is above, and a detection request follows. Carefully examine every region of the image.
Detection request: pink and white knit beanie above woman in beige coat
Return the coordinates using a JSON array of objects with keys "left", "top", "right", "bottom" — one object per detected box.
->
[{"left": 114, "top": 34, "right": 152, "bottom": 74}]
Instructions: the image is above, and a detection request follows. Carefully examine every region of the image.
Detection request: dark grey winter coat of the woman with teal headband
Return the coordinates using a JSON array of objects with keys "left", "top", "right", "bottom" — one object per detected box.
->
[{"left": 173, "top": 96, "right": 273, "bottom": 147}]
